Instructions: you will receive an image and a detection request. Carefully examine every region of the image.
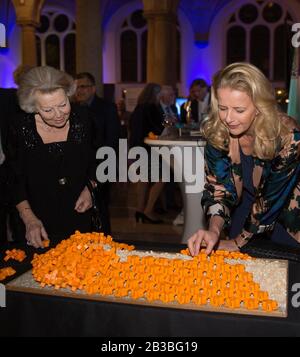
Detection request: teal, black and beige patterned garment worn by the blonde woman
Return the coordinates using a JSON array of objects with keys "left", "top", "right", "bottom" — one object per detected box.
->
[{"left": 202, "top": 116, "right": 300, "bottom": 244}]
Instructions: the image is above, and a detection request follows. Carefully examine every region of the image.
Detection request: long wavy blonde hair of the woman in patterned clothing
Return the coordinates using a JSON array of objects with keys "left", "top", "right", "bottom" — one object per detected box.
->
[{"left": 202, "top": 63, "right": 288, "bottom": 160}]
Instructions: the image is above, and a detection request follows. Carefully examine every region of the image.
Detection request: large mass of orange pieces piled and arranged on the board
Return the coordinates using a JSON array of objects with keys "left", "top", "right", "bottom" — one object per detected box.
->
[{"left": 32, "top": 232, "right": 278, "bottom": 311}]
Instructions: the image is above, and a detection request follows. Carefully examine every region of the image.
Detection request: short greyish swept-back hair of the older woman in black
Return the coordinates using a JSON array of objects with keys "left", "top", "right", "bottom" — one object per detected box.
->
[{"left": 18, "top": 66, "right": 76, "bottom": 113}]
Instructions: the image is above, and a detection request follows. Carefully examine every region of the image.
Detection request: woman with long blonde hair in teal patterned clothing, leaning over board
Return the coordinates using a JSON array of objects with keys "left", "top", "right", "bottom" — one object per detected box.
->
[{"left": 188, "top": 63, "right": 300, "bottom": 255}]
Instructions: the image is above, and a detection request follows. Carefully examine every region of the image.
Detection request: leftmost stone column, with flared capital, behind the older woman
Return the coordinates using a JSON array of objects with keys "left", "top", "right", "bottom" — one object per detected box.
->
[{"left": 12, "top": 0, "right": 44, "bottom": 66}]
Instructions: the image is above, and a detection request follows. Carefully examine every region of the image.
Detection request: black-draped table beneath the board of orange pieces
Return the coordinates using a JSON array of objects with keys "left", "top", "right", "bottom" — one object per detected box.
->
[{"left": 0, "top": 239, "right": 300, "bottom": 337}]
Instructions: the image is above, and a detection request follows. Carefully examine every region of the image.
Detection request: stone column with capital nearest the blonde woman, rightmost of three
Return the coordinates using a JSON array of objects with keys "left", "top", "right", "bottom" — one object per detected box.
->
[{"left": 143, "top": 0, "right": 179, "bottom": 87}]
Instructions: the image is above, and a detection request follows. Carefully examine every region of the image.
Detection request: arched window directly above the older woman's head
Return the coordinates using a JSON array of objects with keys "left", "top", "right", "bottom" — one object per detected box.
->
[{"left": 36, "top": 11, "right": 76, "bottom": 75}]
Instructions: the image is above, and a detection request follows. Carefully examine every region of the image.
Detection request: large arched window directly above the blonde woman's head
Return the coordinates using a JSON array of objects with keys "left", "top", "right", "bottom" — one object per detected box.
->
[{"left": 226, "top": 0, "right": 293, "bottom": 85}]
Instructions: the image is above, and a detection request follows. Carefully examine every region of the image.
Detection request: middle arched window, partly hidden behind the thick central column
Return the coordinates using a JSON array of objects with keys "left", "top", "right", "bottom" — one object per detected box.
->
[{"left": 120, "top": 10, "right": 181, "bottom": 83}]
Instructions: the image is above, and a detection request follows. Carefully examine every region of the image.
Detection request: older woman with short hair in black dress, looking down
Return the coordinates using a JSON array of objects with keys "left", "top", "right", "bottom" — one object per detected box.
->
[{"left": 10, "top": 67, "right": 95, "bottom": 248}]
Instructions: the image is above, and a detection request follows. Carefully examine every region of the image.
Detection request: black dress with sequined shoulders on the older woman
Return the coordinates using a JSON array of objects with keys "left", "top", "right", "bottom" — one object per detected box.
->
[{"left": 10, "top": 108, "right": 96, "bottom": 238}]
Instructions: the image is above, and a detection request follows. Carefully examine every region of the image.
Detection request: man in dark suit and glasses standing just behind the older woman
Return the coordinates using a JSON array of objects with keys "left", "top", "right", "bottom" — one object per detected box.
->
[{"left": 75, "top": 72, "right": 120, "bottom": 235}]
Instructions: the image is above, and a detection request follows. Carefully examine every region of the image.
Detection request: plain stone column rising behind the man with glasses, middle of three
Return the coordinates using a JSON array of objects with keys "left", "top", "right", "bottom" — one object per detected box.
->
[{"left": 76, "top": 0, "right": 103, "bottom": 95}]
